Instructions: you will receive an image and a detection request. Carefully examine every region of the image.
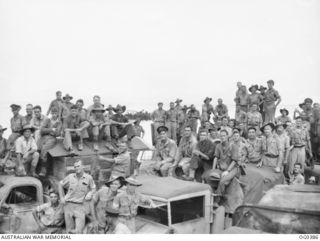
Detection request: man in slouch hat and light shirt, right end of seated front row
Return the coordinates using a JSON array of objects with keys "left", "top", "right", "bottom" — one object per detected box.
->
[{"left": 258, "top": 122, "right": 283, "bottom": 173}]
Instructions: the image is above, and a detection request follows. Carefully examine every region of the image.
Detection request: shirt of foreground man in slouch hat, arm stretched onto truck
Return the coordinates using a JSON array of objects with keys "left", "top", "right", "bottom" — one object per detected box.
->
[{"left": 113, "top": 192, "right": 151, "bottom": 217}]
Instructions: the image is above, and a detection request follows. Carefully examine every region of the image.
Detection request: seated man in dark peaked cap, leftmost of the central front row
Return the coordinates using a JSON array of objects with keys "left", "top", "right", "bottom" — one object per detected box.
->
[{"left": 140, "top": 126, "right": 178, "bottom": 177}]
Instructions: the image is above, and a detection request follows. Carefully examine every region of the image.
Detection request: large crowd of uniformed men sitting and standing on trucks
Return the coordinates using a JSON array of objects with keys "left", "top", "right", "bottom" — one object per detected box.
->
[{"left": 0, "top": 80, "right": 320, "bottom": 233}]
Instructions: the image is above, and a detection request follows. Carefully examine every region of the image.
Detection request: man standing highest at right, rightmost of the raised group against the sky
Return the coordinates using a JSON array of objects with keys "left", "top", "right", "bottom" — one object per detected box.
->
[{"left": 263, "top": 80, "right": 281, "bottom": 123}]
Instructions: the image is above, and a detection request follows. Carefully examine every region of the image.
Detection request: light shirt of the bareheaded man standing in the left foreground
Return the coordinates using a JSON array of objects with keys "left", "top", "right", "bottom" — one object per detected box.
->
[{"left": 60, "top": 173, "right": 96, "bottom": 203}]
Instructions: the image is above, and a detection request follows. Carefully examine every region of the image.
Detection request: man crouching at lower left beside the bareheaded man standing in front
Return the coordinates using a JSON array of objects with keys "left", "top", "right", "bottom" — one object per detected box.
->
[{"left": 32, "top": 190, "right": 64, "bottom": 234}]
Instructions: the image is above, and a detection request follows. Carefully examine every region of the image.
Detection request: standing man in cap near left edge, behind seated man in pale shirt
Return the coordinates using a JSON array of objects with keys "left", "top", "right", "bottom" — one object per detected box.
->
[{"left": 8, "top": 104, "right": 23, "bottom": 149}]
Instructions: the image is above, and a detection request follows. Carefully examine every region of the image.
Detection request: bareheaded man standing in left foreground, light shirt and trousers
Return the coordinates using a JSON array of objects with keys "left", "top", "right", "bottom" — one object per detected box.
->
[{"left": 59, "top": 160, "right": 96, "bottom": 234}]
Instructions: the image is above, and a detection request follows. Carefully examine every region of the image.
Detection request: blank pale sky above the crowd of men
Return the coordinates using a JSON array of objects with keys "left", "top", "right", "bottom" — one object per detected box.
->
[{"left": 0, "top": 0, "right": 320, "bottom": 136}]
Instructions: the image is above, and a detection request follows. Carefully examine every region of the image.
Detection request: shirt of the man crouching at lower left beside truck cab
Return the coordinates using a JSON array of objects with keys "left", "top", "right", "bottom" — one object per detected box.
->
[{"left": 37, "top": 202, "right": 64, "bottom": 226}]
